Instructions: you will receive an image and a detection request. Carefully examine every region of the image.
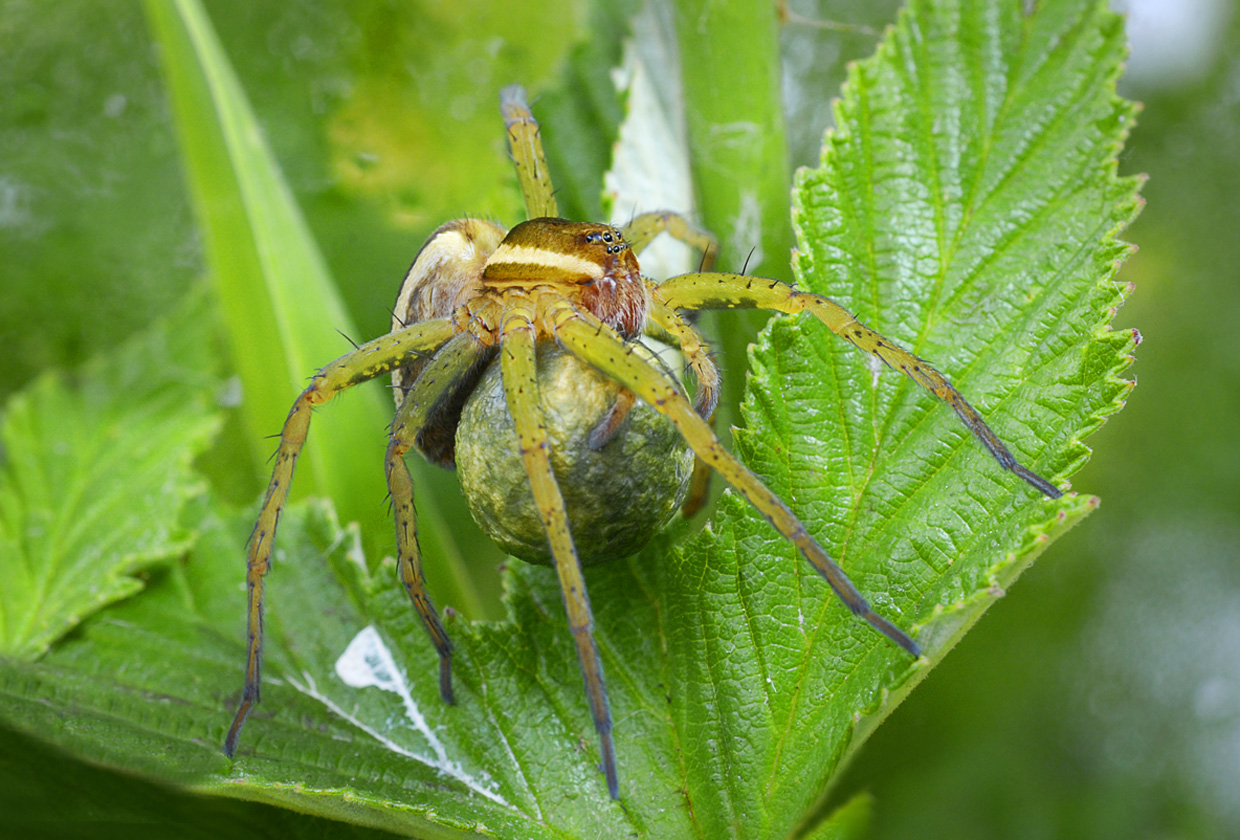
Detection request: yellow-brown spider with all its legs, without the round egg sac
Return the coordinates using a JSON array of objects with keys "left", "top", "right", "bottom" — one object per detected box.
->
[{"left": 223, "top": 86, "right": 1061, "bottom": 799}]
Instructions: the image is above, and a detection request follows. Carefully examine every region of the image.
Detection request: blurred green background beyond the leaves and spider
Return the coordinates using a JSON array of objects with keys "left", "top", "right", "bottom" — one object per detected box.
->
[{"left": 0, "top": 0, "right": 1240, "bottom": 838}]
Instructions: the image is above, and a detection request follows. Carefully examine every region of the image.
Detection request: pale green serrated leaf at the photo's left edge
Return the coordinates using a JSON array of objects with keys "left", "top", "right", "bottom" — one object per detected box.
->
[{"left": 0, "top": 287, "right": 221, "bottom": 660}]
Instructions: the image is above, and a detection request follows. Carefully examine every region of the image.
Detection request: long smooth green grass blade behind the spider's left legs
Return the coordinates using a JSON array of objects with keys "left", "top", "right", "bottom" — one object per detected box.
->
[{"left": 146, "top": 0, "right": 477, "bottom": 608}]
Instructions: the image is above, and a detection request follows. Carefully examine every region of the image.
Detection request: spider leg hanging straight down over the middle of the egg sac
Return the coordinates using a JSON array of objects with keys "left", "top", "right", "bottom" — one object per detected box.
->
[{"left": 500, "top": 304, "right": 620, "bottom": 799}]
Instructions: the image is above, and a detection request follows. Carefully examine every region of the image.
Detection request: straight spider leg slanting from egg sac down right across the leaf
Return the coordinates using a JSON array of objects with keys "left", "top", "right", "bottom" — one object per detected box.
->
[{"left": 547, "top": 297, "right": 921, "bottom": 656}]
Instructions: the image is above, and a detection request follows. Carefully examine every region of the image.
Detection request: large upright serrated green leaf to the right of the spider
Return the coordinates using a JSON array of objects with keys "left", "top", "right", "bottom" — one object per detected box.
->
[{"left": 672, "top": 1, "right": 1138, "bottom": 836}]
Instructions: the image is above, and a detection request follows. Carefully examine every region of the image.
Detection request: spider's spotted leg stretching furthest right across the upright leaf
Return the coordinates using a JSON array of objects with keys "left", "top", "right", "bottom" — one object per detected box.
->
[{"left": 652, "top": 273, "right": 1064, "bottom": 499}]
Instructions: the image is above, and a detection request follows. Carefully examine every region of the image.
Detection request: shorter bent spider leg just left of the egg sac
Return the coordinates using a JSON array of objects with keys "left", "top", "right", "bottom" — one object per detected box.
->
[{"left": 384, "top": 333, "right": 487, "bottom": 705}]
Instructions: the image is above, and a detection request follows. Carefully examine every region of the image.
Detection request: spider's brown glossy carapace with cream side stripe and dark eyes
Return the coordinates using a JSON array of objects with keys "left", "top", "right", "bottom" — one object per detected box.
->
[{"left": 482, "top": 218, "right": 650, "bottom": 337}]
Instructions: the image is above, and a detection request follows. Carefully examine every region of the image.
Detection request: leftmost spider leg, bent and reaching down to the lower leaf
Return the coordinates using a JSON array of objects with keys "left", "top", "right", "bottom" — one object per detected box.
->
[{"left": 224, "top": 319, "right": 453, "bottom": 756}]
